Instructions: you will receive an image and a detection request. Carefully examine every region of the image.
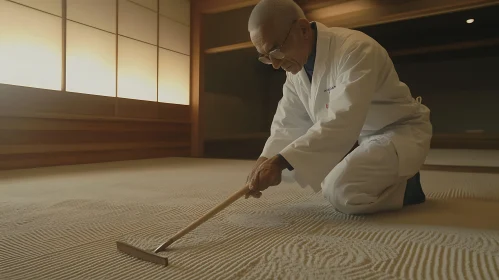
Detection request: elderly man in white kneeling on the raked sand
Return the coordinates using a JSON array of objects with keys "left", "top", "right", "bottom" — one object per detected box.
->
[{"left": 247, "top": 0, "right": 432, "bottom": 217}]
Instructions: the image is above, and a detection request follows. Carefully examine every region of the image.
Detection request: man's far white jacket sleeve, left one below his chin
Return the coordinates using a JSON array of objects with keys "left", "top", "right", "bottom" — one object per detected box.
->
[{"left": 261, "top": 74, "right": 313, "bottom": 158}]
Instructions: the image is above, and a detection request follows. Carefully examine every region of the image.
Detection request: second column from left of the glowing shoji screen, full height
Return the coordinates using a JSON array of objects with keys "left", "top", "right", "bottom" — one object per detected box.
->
[{"left": 66, "top": 0, "right": 116, "bottom": 96}]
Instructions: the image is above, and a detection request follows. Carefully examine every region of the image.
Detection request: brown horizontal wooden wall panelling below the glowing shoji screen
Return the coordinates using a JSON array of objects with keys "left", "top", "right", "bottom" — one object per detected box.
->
[{"left": 0, "top": 81, "right": 192, "bottom": 169}]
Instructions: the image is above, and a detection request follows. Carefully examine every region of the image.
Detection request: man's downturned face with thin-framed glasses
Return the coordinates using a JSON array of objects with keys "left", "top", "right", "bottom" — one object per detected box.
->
[{"left": 250, "top": 23, "right": 308, "bottom": 74}]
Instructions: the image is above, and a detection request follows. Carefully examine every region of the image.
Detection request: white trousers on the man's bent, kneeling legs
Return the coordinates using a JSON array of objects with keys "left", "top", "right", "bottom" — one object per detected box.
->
[{"left": 322, "top": 135, "right": 408, "bottom": 214}]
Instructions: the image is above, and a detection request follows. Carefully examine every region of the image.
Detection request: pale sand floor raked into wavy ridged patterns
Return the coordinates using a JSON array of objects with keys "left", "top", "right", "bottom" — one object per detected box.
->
[{"left": 0, "top": 159, "right": 499, "bottom": 280}]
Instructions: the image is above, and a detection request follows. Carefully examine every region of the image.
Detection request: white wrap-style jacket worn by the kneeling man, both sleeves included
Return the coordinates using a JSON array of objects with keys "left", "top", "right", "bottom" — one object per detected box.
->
[{"left": 261, "top": 23, "right": 432, "bottom": 191}]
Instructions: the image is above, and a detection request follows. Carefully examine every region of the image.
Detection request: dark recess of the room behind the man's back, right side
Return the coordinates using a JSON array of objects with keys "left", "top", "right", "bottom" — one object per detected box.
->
[{"left": 359, "top": 6, "right": 499, "bottom": 133}]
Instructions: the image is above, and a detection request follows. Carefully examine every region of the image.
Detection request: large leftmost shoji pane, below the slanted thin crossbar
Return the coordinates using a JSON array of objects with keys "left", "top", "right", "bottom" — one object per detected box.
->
[{"left": 0, "top": 1, "right": 62, "bottom": 90}]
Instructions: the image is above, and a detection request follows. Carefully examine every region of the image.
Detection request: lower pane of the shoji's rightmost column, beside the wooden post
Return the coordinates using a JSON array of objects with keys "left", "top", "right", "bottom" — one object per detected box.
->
[{"left": 158, "top": 49, "right": 190, "bottom": 105}]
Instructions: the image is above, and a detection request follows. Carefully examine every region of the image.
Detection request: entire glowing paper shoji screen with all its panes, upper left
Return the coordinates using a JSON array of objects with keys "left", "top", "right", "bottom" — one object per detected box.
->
[{"left": 0, "top": 0, "right": 190, "bottom": 104}]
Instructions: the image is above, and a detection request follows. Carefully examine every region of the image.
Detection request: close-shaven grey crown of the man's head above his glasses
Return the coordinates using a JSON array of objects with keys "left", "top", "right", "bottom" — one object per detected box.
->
[{"left": 248, "top": 0, "right": 306, "bottom": 34}]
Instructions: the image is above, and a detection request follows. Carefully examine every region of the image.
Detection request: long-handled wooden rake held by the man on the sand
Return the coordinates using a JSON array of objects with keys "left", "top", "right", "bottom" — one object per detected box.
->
[{"left": 116, "top": 186, "right": 249, "bottom": 266}]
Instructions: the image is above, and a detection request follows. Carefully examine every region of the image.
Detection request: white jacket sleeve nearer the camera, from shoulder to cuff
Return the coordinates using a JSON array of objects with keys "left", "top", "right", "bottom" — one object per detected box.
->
[{"left": 281, "top": 42, "right": 383, "bottom": 189}]
